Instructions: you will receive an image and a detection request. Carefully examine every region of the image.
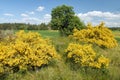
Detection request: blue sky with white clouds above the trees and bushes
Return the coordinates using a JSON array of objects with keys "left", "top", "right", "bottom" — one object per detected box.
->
[{"left": 0, "top": 0, "right": 120, "bottom": 27}]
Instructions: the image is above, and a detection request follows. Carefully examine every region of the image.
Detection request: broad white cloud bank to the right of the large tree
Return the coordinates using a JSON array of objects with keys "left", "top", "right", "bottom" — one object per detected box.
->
[{"left": 76, "top": 11, "right": 120, "bottom": 27}]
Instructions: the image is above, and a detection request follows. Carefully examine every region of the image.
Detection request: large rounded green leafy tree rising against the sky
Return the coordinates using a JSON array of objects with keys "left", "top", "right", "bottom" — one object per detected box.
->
[{"left": 51, "top": 5, "right": 85, "bottom": 36}]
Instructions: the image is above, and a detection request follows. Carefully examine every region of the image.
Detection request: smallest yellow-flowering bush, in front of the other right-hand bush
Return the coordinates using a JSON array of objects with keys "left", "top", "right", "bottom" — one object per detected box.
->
[{"left": 65, "top": 43, "right": 109, "bottom": 68}]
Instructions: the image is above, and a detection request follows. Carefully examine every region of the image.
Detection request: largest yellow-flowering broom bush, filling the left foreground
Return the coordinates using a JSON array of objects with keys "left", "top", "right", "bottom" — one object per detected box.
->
[{"left": 0, "top": 31, "right": 57, "bottom": 72}]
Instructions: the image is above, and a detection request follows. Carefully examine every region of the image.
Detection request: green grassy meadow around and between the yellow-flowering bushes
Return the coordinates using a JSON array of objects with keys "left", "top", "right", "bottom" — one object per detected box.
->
[{"left": 0, "top": 31, "right": 120, "bottom": 80}]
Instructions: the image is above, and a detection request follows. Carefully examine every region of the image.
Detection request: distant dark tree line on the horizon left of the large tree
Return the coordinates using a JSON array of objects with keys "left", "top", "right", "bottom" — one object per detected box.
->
[{"left": 0, "top": 23, "right": 51, "bottom": 30}]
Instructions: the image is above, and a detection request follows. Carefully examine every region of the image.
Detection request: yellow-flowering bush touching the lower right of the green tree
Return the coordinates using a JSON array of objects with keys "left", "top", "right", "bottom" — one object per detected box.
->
[{"left": 71, "top": 22, "right": 117, "bottom": 48}]
